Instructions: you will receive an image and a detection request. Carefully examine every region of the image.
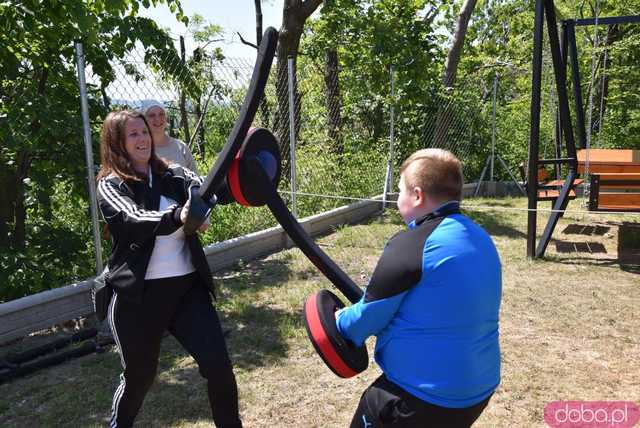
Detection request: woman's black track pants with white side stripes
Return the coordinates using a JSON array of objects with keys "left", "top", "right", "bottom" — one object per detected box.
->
[{"left": 108, "top": 274, "right": 242, "bottom": 428}]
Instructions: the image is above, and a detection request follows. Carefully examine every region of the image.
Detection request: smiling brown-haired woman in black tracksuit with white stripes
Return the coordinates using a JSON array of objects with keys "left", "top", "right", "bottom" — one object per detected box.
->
[{"left": 98, "top": 110, "right": 242, "bottom": 428}]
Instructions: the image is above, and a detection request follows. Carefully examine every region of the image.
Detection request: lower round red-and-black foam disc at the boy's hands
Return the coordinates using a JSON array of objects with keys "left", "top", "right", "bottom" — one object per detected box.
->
[{"left": 304, "top": 290, "right": 369, "bottom": 378}]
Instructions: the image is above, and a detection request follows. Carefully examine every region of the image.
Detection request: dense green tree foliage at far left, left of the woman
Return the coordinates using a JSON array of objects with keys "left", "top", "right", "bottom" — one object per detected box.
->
[{"left": 0, "top": 0, "right": 186, "bottom": 302}]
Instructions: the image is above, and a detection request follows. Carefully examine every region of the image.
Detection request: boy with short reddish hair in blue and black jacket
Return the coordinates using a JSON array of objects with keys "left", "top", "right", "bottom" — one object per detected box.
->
[{"left": 336, "top": 149, "right": 502, "bottom": 428}]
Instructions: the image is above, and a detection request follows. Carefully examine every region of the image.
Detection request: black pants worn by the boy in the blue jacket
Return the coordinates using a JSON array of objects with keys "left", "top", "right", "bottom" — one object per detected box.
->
[{"left": 351, "top": 375, "right": 491, "bottom": 428}]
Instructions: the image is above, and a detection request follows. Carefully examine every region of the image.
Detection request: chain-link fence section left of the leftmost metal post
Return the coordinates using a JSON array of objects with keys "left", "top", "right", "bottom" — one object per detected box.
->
[{"left": 0, "top": 49, "right": 100, "bottom": 302}]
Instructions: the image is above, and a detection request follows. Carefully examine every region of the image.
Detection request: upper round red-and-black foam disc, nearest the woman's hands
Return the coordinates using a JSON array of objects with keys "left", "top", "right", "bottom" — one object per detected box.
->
[{"left": 227, "top": 128, "right": 282, "bottom": 207}]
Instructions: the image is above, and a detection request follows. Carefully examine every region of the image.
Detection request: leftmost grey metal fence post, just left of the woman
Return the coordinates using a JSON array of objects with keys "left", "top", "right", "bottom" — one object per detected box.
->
[{"left": 75, "top": 41, "right": 102, "bottom": 275}]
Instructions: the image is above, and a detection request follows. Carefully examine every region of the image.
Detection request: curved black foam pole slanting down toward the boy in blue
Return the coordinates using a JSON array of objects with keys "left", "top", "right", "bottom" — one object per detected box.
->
[{"left": 246, "top": 157, "right": 363, "bottom": 303}]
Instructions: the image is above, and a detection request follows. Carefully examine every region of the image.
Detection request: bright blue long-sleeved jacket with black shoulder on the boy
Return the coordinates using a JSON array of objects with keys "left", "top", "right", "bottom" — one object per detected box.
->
[{"left": 337, "top": 202, "right": 502, "bottom": 408}]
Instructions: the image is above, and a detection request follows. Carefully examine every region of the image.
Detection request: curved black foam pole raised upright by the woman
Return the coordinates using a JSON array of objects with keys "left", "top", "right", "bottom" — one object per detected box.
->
[{"left": 200, "top": 27, "right": 278, "bottom": 201}]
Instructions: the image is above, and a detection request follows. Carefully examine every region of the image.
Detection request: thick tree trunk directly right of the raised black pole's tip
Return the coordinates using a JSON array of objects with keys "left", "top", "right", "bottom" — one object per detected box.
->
[{"left": 274, "top": 0, "right": 322, "bottom": 177}]
